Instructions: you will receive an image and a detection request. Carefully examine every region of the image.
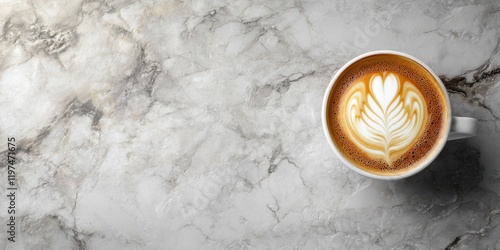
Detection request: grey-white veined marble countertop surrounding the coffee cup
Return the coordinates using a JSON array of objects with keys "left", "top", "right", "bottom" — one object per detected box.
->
[{"left": 0, "top": 0, "right": 500, "bottom": 249}]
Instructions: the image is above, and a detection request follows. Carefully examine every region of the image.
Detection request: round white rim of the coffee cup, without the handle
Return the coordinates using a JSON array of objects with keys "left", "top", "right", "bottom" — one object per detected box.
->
[{"left": 321, "top": 50, "right": 452, "bottom": 180}]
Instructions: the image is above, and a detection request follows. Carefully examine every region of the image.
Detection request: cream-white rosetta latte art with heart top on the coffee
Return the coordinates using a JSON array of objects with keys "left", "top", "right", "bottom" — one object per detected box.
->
[{"left": 340, "top": 72, "right": 427, "bottom": 166}]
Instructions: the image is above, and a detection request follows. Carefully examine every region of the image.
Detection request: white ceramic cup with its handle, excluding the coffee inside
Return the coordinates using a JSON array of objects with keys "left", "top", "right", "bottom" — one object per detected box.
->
[{"left": 322, "top": 50, "right": 477, "bottom": 180}]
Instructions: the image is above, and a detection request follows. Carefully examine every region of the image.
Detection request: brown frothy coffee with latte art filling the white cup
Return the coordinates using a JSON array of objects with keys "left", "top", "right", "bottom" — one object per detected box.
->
[{"left": 327, "top": 54, "right": 450, "bottom": 175}]
